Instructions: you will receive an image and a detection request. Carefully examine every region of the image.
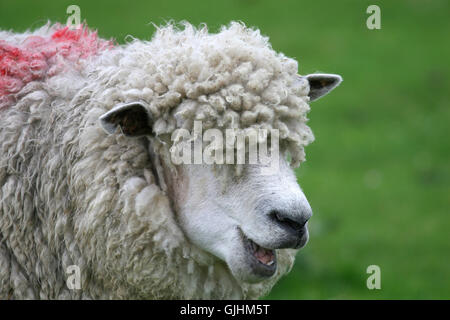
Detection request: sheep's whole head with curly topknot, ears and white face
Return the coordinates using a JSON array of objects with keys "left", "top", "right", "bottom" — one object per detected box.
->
[{"left": 95, "top": 24, "right": 342, "bottom": 294}]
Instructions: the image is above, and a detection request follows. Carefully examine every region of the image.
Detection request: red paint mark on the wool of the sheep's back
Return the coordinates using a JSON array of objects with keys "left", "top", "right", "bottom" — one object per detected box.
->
[{"left": 0, "top": 25, "right": 113, "bottom": 109}]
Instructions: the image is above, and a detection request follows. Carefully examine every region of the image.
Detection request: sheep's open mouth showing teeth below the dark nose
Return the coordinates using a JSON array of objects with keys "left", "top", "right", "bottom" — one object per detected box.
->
[{"left": 242, "top": 230, "right": 277, "bottom": 278}]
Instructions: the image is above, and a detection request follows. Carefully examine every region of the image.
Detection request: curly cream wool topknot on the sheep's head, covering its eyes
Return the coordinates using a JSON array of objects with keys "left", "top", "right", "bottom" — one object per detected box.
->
[{"left": 92, "top": 23, "right": 314, "bottom": 167}]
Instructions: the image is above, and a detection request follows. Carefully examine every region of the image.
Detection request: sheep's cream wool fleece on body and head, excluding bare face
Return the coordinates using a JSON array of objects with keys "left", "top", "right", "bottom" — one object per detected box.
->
[{"left": 0, "top": 23, "right": 313, "bottom": 299}]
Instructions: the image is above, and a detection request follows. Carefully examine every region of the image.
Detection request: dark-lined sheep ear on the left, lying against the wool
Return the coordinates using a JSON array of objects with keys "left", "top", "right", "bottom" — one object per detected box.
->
[{"left": 100, "top": 102, "right": 152, "bottom": 137}]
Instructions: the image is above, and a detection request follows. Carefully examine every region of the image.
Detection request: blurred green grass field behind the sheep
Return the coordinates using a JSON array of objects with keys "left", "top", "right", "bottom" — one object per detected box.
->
[{"left": 0, "top": 0, "right": 450, "bottom": 299}]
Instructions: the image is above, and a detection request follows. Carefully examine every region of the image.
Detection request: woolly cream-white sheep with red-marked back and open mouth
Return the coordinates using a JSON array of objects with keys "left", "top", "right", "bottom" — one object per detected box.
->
[{"left": 0, "top": 22, "right": 342, "bottom": 299}]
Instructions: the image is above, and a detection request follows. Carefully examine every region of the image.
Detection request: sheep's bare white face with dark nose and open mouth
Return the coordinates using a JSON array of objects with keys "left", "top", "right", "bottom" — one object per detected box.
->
[{"left": 170, "top": 159, "right": 312, "bottom": 282}]
